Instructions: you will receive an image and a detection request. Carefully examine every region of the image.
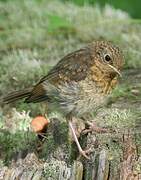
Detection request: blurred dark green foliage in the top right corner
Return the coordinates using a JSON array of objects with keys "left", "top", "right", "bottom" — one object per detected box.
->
[{"left": 62, "top": 0, "right": 141, "bottom": 18}]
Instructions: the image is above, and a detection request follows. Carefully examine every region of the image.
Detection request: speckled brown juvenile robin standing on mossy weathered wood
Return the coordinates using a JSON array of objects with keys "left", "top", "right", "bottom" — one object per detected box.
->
[{"left": 3, "top": 41, "right": 123, "bottom": 158}]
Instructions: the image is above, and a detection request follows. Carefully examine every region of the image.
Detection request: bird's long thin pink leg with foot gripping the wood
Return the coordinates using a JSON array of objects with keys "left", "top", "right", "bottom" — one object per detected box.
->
[{"left": 69, "top": 120, "right": 92, "bottom": 159}]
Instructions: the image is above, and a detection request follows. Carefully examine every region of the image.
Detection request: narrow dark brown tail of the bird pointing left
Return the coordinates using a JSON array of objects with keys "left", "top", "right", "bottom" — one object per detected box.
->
[{"left": 2, "top": 89, "right": 31, "bottom": 104}]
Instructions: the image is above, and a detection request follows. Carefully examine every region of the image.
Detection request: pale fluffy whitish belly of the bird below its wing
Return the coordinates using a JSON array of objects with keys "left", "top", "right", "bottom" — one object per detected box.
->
[{"left": 47, "top": 80, "right": 106, "bottom": 116}]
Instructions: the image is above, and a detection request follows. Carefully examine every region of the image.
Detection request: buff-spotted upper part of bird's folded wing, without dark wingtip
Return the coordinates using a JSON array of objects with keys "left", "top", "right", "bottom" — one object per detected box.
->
[{"left": 39, "top": 48, "right": 92, "bottom": 83}]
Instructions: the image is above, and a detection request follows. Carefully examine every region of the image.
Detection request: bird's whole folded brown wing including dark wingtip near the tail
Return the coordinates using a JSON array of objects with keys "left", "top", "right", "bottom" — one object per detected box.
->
[{"left": 26, "top": 48, "right": 92, "bottom": 102}]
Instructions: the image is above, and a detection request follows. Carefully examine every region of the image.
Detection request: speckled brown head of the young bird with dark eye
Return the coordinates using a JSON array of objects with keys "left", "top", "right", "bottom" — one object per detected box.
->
[{"left": 93, "top": 41, "right": 124, "bottom": 78}]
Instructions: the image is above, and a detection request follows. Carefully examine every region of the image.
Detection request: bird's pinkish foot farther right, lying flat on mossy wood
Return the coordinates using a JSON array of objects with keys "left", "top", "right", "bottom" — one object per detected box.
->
[{"left": 82, "top": 121, "right": 109, "bottom": 134}]
